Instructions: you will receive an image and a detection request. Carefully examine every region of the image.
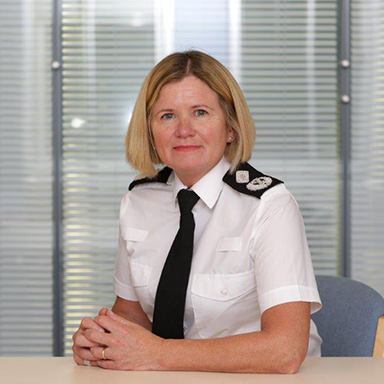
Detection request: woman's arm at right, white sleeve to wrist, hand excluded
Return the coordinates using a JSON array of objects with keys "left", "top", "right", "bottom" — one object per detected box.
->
[{"left": 154, "top": 194, "right": 314, "bottom": 373}]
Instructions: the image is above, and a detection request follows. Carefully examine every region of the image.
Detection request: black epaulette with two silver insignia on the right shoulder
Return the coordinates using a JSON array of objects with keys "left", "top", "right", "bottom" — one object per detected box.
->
[{"left": 223, "top": 163, "right": 283, "bottom": 199}]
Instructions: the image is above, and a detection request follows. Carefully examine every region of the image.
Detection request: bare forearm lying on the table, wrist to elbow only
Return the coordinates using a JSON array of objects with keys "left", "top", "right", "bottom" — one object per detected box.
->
[{"left": 161, "top": 331, "right": 303, "bottom": 373}]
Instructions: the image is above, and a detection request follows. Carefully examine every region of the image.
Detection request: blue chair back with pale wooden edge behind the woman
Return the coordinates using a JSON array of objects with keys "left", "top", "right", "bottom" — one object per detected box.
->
[{"left": 312, "top": 276, "right": 384, "bottom": 357}]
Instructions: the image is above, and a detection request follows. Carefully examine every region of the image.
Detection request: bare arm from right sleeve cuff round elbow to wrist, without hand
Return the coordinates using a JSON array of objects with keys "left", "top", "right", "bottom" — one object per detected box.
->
[{"left": 162, "top": 302, "right": 310, "bottom": 373}]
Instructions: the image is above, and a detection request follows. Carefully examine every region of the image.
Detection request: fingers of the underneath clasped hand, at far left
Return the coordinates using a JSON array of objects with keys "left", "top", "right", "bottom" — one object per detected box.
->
[{"left": 72, "top": 316, "right": 107, "bottom": 367}]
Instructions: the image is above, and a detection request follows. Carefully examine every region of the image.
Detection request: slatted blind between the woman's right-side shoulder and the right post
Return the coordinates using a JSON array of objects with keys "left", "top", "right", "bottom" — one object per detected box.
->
[{"left": 239, "top": 0, "right": 340, "bottom": 275}]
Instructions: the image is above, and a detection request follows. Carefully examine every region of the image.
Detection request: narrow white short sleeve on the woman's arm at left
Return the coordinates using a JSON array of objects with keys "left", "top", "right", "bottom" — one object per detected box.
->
[{"left": 114, "top": 193, "right": 139, "bottom": 301}]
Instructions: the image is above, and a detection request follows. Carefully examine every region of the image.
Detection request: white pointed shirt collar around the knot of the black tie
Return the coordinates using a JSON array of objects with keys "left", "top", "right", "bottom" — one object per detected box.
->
[{"left": 167, "top": 157, "right": 231, "bottom": 209}]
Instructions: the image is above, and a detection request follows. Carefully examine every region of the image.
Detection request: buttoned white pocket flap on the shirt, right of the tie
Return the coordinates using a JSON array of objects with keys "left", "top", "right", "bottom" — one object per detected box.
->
[{"left": 191, "top": 269, "right": 256, "bottom": 301}]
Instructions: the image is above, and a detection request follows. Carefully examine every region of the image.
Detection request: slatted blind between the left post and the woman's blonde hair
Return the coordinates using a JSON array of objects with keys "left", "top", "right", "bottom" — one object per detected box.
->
[{"left": 62, "top": 0, "right": 155, "bottom": 355}]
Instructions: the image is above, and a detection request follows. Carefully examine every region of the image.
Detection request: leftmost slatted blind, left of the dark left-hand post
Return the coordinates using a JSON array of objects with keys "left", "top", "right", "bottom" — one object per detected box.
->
[{"left": 0, "top": 0, "right": 53, "bottom": 356}]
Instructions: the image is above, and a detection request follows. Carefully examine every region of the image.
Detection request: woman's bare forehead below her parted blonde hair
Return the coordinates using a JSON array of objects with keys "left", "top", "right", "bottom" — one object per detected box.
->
[{"left": 155, "top": 76, "right": 219, "bottom": 104}]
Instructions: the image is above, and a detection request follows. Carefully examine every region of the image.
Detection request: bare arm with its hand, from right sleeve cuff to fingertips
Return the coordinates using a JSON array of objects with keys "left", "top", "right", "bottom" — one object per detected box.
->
[{"left": 85, "top": 302, "right": 310, "bottom": 373}]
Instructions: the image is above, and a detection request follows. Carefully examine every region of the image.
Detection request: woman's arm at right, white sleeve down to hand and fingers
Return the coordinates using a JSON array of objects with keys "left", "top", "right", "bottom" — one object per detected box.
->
[{"left": 86, "top": 189, "right": 319, "bottom": 373}]
